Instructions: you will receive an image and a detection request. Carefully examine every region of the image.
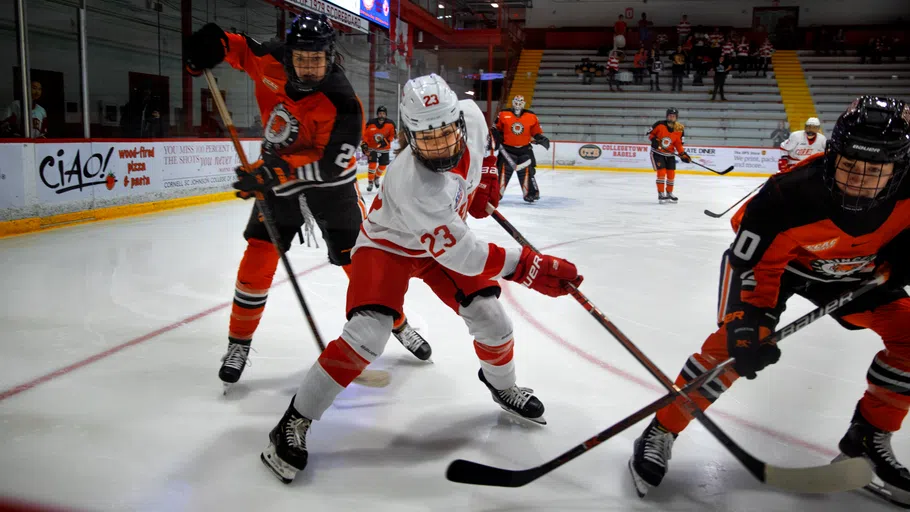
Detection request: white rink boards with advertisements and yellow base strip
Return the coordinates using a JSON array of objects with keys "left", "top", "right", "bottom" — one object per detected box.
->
[{"left": 0, "top": 139, "right": 779, "bottom": 236}]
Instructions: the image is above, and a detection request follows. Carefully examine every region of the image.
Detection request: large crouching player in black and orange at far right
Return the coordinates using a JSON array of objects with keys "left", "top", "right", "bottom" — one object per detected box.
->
[{"left": 629, "top": 96, "right": 910, "bottom": 504}]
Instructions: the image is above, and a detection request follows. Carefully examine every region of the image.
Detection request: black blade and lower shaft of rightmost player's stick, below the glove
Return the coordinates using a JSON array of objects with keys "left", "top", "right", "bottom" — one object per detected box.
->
[{"left": 446, "top": 360, "right": 733, "bottom": 487}]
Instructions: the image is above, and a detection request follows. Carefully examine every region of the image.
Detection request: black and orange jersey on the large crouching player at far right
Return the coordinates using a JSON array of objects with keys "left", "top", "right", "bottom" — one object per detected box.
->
[{"left": 722, "top": 155, "right": 910, "bottom": 312}]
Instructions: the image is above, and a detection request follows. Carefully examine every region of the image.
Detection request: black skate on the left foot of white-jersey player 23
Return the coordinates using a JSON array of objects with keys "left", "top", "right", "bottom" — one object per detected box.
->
[{"left": 259, "top": 398, "right": 313, "bottom": 484}]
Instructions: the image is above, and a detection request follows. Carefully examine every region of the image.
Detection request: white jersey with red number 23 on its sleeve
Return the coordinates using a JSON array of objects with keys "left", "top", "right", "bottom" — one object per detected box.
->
[{"left": 360, "top": 100, "right": 521, "bottom": 279}]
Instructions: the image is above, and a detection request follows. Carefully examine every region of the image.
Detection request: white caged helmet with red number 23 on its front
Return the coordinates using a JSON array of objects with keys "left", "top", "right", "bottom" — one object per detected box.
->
[{"left": 400, "top": 73, "right": 467, "bottom": 172}]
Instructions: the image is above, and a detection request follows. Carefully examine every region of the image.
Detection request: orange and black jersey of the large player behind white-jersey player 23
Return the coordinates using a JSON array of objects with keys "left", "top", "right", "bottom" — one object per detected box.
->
[{"left": 225, "top": 34, "right": 363, "bottom": 195}]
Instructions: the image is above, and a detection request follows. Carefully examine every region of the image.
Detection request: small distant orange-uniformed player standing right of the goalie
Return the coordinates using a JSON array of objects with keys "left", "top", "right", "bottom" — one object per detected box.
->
[{"left": 648, "top": 107, "right": 692, "bottom": 204}]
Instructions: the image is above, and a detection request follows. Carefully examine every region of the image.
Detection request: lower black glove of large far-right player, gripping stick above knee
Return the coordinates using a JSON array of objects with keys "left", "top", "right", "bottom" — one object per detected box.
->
[{"left": 724, "top": 304, "right": 780, "bottom": 380}]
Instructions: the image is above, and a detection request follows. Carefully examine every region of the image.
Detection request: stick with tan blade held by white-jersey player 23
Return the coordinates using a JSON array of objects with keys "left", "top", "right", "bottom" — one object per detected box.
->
[{"left": 470, "top": 205, "right": 877, "bottom": 493}]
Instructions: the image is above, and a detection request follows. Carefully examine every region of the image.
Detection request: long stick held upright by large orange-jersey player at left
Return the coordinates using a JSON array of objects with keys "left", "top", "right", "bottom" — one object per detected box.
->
[{"left": 205, "top": 69, "right": 390, "bottom": 388}]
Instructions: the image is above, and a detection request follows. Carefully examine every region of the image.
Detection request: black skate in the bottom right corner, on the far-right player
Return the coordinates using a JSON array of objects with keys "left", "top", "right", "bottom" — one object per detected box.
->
[{"left": 834, "top": 407, "right": 910, "bottom": 508}]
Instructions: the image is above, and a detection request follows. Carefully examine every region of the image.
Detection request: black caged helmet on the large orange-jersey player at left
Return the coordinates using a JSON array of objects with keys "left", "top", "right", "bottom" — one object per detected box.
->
[{"left": 284, "top": 13, "right": 335, "bottom": 92}]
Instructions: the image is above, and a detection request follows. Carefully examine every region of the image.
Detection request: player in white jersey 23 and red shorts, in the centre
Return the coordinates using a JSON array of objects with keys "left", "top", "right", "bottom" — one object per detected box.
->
[{"left": 261, "top": 74, "right": 582, "bottom": 483}]
